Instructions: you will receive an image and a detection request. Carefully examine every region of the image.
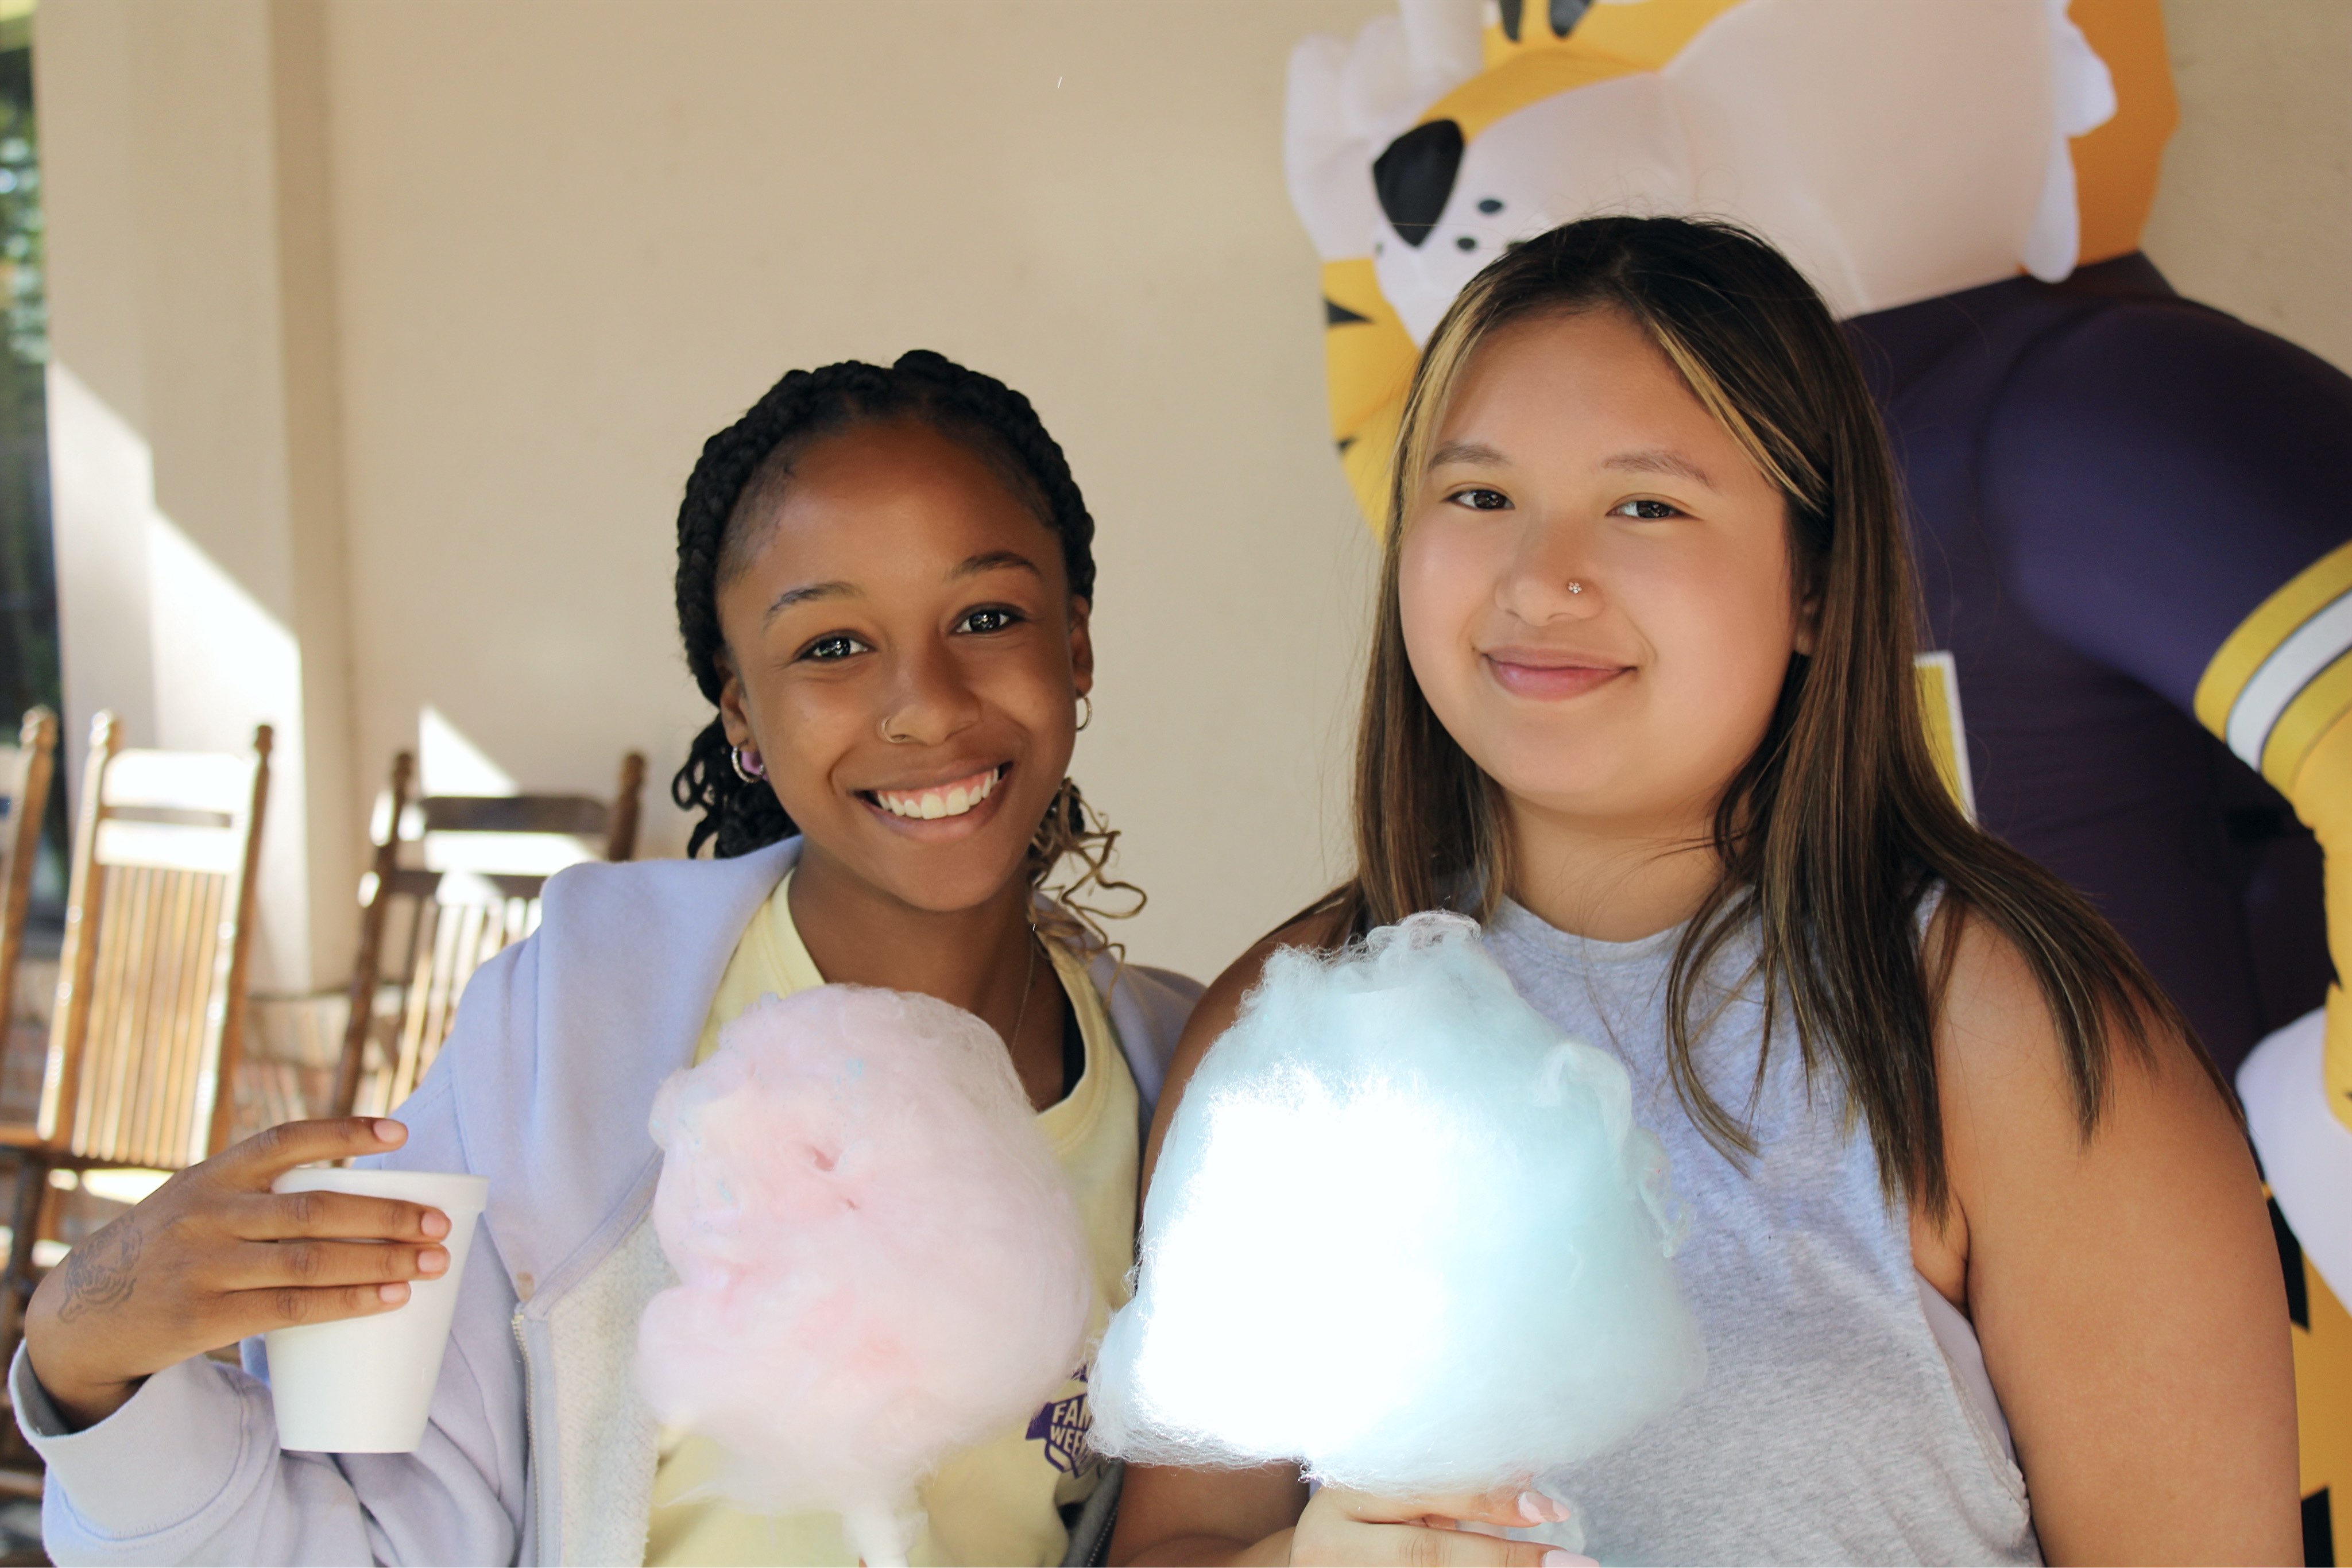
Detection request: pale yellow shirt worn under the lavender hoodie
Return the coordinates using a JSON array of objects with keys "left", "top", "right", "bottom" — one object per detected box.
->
[{"left": 644, "top": 874, "right": 1138, "bottom": 1568}]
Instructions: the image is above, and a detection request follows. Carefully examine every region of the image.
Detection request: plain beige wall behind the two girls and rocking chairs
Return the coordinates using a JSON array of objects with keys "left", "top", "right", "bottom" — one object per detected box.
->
[{"left": 35, "top": 0, "right": 2352, "bottom": 985}]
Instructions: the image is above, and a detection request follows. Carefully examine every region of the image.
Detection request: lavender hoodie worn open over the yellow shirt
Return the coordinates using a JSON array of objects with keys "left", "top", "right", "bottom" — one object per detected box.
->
[{"left": 9, "top": 839, "right": 1200, "bottom": 1563}]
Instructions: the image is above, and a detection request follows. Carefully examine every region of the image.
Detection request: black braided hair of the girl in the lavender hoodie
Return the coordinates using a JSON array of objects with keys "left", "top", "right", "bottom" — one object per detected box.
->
[{"left": 670, "top": 348, "right": 1094, "bottom": 877}]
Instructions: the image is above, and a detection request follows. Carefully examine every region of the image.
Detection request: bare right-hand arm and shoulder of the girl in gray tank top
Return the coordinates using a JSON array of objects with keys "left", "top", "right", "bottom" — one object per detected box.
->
[{"left": 1912, "top": 912, "right": 2298, "bottom": 1563}]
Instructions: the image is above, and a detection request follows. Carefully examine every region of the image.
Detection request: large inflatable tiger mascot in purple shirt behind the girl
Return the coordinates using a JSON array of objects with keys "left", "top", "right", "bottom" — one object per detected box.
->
[{"left": 1284, "top": 0, "right": 2352, "bottom": 1563}]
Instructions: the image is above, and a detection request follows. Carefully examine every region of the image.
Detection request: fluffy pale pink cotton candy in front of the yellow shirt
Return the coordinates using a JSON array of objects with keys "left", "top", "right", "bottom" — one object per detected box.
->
[{"left": 637, "top": 985, "right": 1094, "bottom": 1563}]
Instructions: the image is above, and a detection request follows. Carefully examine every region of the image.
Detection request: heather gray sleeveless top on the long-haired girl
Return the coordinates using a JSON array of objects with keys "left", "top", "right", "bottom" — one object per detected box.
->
[{"left": 1487, "top": 905, "right": 2041, "bottom": 1563}]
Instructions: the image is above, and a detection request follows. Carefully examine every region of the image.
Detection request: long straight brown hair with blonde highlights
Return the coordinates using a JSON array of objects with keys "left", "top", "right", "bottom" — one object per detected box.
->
[{"left": 1322, "top": 216, "right": 2230, "bottom": 1215}]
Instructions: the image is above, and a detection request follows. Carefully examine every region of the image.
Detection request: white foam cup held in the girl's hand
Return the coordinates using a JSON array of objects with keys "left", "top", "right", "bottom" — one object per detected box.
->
[{"left": 264, "top": 1168, "right": 489, "bottom": 1453}]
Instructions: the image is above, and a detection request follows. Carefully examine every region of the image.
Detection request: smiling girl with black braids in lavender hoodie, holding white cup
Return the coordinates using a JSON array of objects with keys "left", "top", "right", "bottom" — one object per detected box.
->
[{"left": 9, "top": 353, "right": 1200, "bottom": 1563}]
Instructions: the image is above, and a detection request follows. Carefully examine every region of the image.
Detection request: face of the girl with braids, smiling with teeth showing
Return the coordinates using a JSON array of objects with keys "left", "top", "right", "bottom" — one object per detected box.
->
[{"left": 717, "top": 421, "right": 1094, "bottom": 915}]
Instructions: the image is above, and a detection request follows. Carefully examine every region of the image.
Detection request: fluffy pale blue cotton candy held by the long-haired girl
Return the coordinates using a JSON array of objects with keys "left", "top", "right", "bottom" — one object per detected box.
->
[{"left": 1092, "top": 915, "right": 1705, "bottom": 1497}]
